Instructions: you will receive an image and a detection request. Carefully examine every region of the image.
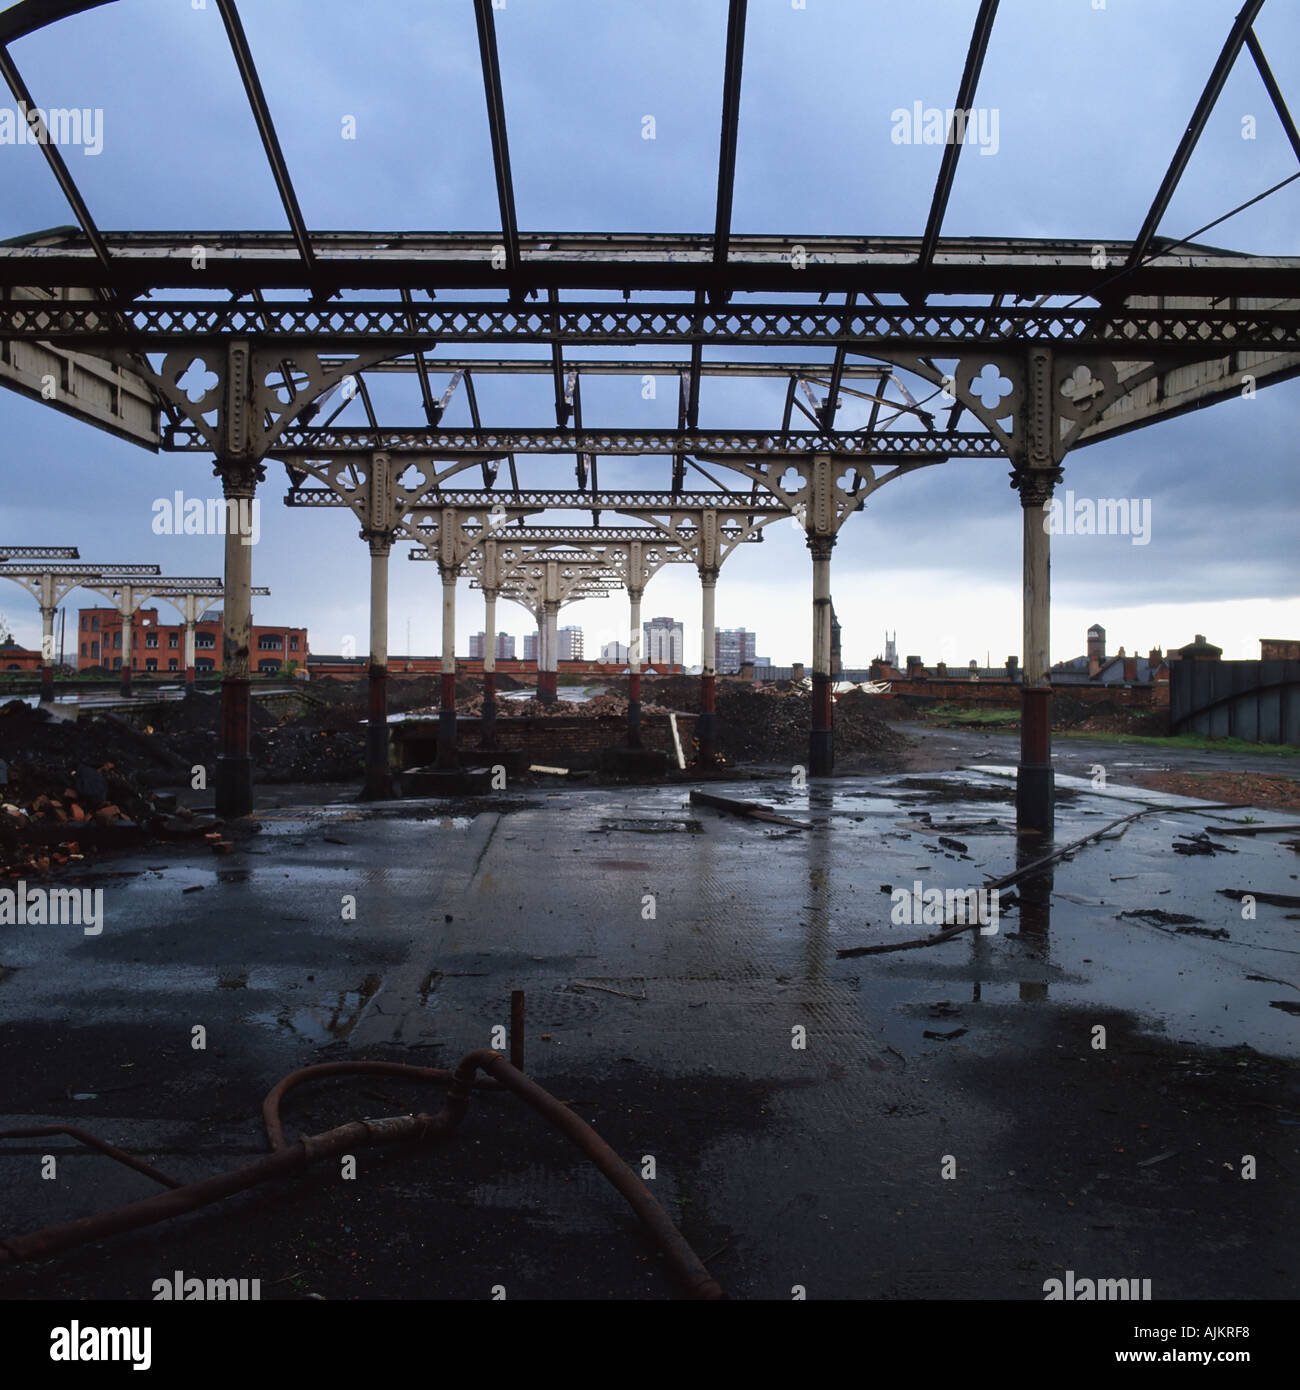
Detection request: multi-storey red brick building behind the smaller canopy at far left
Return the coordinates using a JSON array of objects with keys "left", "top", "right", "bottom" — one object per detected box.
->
[{"left": 76, "top": 607, "right": 309, "bottom": 676}]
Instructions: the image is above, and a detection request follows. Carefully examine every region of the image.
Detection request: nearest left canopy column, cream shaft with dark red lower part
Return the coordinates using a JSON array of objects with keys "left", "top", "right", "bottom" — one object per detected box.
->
[{"left": 214, "top": 459, "right": 266, "bottom": 819}]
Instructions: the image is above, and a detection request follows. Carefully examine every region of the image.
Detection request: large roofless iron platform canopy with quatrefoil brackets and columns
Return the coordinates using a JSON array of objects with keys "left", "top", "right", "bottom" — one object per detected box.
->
[{"left": 0, "top": 0, "right": 1300, "bottom": 811}]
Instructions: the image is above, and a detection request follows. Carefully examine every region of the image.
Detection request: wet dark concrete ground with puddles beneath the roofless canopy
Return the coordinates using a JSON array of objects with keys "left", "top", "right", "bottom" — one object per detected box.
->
[{"left": 0, "top": 750, "right": 1300, "bottom": 1300}]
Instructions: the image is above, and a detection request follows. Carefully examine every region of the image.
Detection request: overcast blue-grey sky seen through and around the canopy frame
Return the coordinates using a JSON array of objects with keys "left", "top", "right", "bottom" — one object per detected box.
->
[{"left": 0, "top": 0, "right": 1300, "bottom": 666}]
